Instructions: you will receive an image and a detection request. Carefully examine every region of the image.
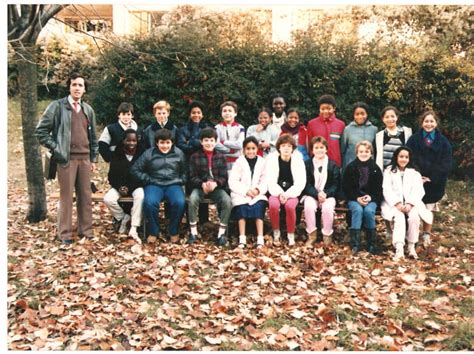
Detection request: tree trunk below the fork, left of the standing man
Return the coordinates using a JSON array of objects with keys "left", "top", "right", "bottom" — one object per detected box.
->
[{"left": 15, "top": 45, "right": 47, "bottom": 223}]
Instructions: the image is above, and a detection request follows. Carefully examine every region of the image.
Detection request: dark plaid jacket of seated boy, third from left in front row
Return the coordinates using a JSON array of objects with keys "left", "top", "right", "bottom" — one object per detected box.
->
[{"left": 189, "top": 149, "right": 228, "bottom": 189}]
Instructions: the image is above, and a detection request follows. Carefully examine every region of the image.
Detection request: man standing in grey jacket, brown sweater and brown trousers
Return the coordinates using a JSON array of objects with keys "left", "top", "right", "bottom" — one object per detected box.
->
[{"left": 35, "top": 74, "right": 98, "bottom": 244}]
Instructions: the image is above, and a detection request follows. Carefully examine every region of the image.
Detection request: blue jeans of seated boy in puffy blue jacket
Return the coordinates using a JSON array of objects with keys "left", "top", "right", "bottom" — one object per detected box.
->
[{"left": 143, "top": 184, "right": 186, "bottom": 236}]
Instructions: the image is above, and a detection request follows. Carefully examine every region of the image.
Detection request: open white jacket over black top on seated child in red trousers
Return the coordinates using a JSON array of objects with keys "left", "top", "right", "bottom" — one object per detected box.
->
[{"left": 265, "top": 150, "right": 306, "bottom": 198}]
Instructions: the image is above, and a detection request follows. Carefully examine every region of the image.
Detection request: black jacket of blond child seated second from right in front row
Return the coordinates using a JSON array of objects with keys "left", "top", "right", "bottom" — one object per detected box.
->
[{"left": 342, "top": 158, "right": 383, "bottom": 205}]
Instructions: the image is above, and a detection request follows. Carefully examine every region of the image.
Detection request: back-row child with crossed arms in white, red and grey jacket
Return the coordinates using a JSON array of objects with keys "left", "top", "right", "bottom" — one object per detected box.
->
[{"left": 216, "top": 101, "right": 245, "bottom": 170}]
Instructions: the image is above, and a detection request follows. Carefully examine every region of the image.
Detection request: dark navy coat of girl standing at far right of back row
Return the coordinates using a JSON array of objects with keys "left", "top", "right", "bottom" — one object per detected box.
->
[{"left": 407, "top": 130, "right": 453, "bottom": 203}]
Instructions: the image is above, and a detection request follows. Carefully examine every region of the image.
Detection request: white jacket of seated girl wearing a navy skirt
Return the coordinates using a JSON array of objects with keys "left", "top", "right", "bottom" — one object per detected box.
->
[{"left": 228, "top": 155, "right": 267, "bottom": 206}]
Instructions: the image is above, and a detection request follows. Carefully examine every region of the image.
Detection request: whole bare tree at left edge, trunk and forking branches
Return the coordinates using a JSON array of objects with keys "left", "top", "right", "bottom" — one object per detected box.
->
[{"left": 8, "top": 4, "right": 67, "bottom": 222}]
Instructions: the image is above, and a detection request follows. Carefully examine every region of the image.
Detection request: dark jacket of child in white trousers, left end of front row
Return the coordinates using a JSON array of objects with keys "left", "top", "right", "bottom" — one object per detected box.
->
[{"left": 108, "top": 144, "right": 144, "bottom": 194}]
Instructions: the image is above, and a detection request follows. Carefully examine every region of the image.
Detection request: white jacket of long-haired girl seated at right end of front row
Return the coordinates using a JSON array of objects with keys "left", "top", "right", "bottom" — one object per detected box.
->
[{"left": 381, "top": 166, "right": 433, "bottom": 224}]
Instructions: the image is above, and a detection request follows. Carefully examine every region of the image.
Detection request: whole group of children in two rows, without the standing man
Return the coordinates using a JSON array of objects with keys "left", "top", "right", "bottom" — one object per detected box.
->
[{"left": 99, "top": 95, "right": 452, "bottom": 259}]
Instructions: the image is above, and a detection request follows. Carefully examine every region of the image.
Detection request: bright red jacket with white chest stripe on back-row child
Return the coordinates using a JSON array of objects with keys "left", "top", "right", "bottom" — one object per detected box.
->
[{"left": 307, "top": 114, "right": 346, "bottom": 167}]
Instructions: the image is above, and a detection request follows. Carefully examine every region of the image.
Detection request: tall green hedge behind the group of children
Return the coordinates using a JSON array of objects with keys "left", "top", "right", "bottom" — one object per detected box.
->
[{"left": 9, "top": 15, "right": 474, "bottom": 178}]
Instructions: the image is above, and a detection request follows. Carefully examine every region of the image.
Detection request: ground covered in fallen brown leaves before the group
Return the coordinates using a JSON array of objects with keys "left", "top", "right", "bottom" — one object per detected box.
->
[{"left": 8, "top": 176, "right": 474, "bottom": 350}]
